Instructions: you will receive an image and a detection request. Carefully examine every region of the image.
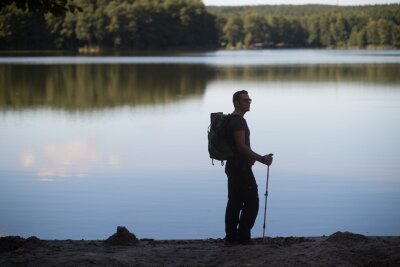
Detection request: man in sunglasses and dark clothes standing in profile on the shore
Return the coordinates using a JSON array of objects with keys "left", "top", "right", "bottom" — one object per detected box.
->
[{"left": 225, "top": 90, "right": 273, "bottom": 245}]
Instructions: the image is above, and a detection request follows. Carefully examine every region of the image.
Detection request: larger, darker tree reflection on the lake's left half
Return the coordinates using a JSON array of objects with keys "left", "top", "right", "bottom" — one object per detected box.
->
[{"left": 0, "top": 65, "right": 213, "bottom": 110}]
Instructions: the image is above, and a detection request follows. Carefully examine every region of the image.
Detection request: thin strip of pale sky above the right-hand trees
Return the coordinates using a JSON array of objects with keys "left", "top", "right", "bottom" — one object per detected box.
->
[{"left": 203, "top": 0, "right": 400, "bottom": 6}]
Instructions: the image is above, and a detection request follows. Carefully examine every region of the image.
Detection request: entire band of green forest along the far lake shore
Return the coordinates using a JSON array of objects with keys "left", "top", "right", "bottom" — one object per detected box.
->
[{"left": 0, "top": 0, "right": 400, "bottom": 51}]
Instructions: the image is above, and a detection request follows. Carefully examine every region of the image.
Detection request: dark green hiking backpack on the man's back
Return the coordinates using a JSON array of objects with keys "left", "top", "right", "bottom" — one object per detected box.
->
[{"left": 208, "top": 112, "right": 237, "bottom": 166}]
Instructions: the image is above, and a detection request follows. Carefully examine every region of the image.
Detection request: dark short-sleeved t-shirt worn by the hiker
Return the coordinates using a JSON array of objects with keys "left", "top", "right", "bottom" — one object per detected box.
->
[{"left": 225, "top": 115, "right": 251, "bottom": 176}]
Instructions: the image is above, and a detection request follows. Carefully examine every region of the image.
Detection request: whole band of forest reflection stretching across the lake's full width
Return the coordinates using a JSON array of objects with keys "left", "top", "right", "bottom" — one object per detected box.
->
[{"left": 0, "top": 64, "right": 400, "bottom": 111}]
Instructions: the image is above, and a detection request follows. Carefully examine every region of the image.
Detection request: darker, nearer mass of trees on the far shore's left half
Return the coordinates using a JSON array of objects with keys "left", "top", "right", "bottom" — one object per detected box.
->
[{"left": 0, "top": 0, "right": 218, "bottom": 50}]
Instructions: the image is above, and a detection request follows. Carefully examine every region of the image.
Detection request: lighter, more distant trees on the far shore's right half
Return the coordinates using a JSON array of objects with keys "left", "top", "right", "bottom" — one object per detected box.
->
[{"left": 211, "top": 4, "right": 400, "bottom": 48}]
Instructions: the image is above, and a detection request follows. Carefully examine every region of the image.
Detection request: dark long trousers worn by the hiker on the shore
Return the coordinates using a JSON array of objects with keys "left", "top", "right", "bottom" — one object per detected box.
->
[{"left": 225, "top": 166, "right": 259, "bottom": 242}]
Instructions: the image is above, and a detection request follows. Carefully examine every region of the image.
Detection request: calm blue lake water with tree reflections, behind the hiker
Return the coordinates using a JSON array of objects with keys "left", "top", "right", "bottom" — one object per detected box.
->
[{"left": 0, "top": 50, "right": 400, "bottom": 239}]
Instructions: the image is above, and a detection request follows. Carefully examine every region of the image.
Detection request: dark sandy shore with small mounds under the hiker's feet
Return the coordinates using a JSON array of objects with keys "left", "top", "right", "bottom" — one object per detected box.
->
[{"left": 0, "top": 227, "right": 400, "bottom": 267}]
